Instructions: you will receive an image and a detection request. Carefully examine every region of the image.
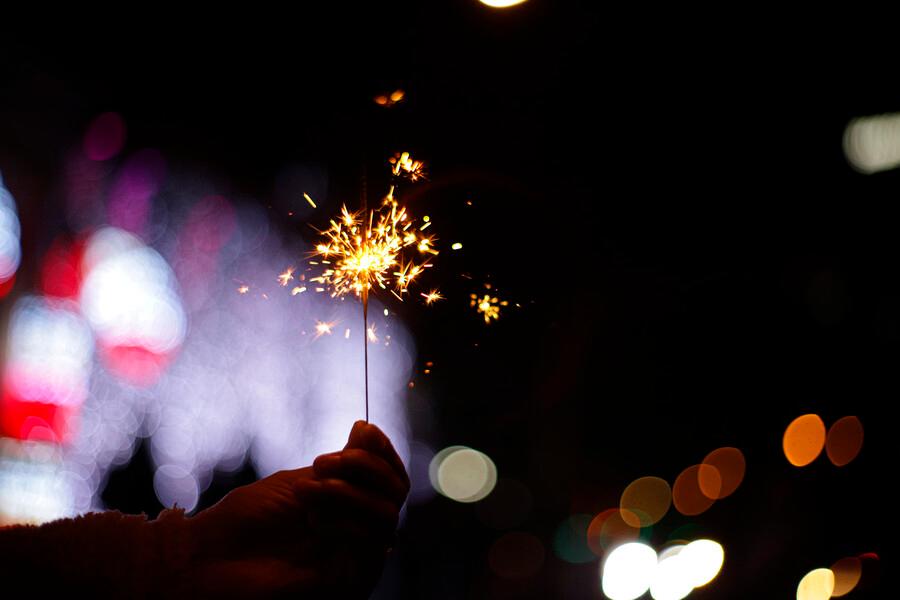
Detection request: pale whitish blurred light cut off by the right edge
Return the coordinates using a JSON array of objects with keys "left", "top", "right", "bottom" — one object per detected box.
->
[{"left": 844, "top": 114, "right": 900, "bottom": 174}]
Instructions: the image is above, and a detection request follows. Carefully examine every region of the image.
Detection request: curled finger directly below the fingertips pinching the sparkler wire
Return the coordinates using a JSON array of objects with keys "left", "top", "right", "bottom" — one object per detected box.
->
[{"left": 313, "top": 448, "right": 409, "bottom": 508}]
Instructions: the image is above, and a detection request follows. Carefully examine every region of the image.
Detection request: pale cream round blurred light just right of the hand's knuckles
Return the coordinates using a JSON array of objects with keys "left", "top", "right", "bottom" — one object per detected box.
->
[{"left": 428, "top": 446, "right": 497, "bottom": 503}]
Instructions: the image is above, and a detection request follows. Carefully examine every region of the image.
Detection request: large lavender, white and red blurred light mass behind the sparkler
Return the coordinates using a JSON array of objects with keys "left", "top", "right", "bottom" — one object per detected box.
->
[{"left": 0, "top": 114, "right": 414, "bottom": 522}]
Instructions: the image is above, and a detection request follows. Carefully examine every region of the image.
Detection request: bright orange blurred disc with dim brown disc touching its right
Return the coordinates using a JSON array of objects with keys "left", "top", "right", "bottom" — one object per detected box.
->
[{"left": 782, "top": 414, "right": 864, "bottom": 467}]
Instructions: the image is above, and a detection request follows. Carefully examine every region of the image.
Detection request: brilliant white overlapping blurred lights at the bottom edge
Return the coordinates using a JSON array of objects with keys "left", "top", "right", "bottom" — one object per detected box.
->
[{"left": 602, "top": 539, "right": 725, "bottom": 600}]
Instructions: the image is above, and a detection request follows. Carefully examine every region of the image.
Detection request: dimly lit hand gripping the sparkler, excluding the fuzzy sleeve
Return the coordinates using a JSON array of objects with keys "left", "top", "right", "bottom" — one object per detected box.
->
[{"left": 187, "top": 421, "right": 409, "bottom": 598}]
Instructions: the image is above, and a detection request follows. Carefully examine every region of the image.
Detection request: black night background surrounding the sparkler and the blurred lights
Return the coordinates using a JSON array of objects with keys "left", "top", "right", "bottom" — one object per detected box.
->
[{"left": 0, "top": 0, "right": 888, "bottom": 598}]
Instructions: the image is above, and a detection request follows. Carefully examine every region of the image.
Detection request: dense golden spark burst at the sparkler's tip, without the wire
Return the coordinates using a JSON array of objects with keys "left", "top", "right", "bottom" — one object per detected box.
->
[{"left": 310, "top": 195, "right": 438, "bottom": 299}]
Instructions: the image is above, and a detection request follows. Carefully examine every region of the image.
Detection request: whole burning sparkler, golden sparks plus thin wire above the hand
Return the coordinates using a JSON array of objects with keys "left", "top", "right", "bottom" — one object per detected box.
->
[{"left": 310, "top": 152, "right": 439, "bottom": 421}]
